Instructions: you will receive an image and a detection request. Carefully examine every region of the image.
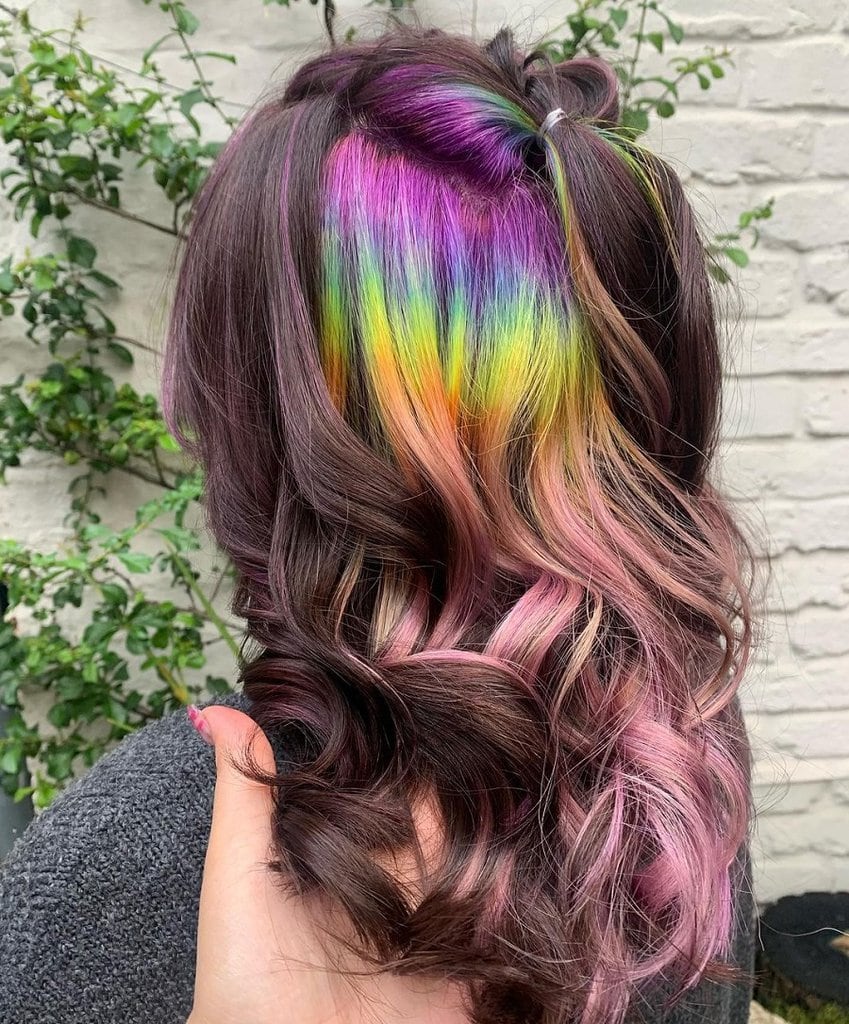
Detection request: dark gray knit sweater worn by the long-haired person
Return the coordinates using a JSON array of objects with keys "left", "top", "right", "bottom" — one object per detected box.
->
[{"left": 0, "top": 694, "right": 753, "bottom": 1024}]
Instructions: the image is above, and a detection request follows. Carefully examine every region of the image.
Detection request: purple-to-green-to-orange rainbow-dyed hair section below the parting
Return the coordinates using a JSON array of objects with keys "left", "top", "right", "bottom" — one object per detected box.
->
[{"left": 320, "top": 86, "right": 602, "bottom": 499}]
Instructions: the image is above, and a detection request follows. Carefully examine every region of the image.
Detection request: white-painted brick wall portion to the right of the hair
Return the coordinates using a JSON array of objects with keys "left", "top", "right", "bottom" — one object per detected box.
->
[{"left": 652, "top": 0, "right": 849, "bottom": 899}]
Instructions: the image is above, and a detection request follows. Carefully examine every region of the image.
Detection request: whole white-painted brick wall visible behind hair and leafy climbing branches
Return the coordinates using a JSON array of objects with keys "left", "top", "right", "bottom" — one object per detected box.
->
[{"left": 0, "top": 0, "right": 849, "bottom": 899}]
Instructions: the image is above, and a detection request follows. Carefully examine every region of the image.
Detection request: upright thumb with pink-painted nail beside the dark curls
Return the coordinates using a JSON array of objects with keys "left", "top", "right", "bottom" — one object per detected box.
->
[{"left": 188, "top": 705, "right": 277, "bottom": 879}]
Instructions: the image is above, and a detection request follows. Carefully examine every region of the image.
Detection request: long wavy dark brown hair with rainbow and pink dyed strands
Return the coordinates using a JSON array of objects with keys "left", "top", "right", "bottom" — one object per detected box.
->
[{"left": 164, "top": 28, "right": 754, "bottom": 1024}]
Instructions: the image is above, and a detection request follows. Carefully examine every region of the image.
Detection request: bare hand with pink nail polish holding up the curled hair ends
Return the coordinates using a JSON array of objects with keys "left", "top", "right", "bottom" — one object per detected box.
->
[{"left": 187, "top": 705, "right": 468, "bottom": 1024}]
